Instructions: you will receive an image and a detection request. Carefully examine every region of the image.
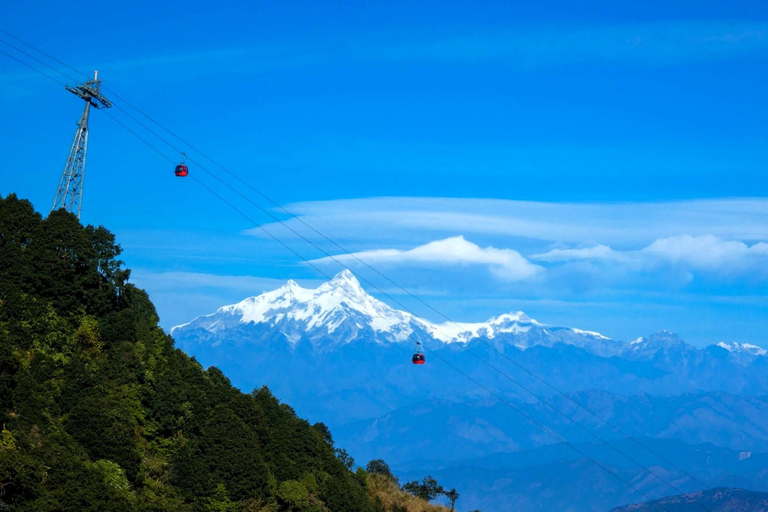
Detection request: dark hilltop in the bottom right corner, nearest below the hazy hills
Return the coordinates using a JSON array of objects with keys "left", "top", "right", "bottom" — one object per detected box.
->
[{"left": 612, "top": 488, "right": 768, "bottom": 512}]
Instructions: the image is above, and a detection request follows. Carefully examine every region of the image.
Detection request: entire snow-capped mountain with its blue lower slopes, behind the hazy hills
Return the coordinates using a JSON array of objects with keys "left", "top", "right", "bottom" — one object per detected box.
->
[{"left": 171, "top": 271, "right": 768, "bottom": 425}]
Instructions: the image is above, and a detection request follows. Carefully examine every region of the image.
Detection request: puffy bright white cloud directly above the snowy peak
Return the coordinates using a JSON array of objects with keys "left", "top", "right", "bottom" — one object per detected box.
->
[{"left": 313, "top": 236, "right": 543, "bottom": 281}]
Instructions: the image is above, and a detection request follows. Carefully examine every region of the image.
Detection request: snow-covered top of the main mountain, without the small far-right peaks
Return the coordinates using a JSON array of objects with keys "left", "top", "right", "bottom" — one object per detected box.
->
[{"left": 171, "top": 270, "right": 623, "bottom": 356}]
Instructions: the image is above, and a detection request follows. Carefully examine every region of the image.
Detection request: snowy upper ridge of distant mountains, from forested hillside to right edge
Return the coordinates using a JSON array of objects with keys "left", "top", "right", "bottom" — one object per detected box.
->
[{"left": 170, "top": 270, "right": 768, "bottom": 366}]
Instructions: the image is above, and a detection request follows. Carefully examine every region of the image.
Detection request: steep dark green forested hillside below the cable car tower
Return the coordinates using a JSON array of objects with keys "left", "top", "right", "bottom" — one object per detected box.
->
[{"left": 0, "top": 195, "right": 444, "bottom": 512}]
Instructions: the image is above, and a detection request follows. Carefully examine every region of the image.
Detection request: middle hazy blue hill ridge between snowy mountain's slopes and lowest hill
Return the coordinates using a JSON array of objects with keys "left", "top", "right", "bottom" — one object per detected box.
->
[{"left": 335, "top": 390, "right": 768, "bottom": 465}]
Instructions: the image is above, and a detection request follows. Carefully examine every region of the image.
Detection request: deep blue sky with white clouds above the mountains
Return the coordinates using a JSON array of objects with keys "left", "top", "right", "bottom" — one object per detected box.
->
[{"left": 0, "top": 1, "right": 768, "bottom": 346}]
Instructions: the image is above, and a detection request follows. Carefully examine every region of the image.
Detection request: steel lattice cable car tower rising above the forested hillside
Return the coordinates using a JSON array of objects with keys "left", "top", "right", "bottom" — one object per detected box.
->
[{"left": 51, "top": 71, "right": 112, "bottom": 219}]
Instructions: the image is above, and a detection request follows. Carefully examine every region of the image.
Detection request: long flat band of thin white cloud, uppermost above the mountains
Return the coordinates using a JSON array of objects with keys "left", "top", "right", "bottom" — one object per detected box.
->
[{"left": 249, "top": 197, "right": 768, "bottom": 249}]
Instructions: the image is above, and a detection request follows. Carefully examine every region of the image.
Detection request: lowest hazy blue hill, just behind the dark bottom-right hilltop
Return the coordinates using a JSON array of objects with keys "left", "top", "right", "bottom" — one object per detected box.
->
[{"left": 401, "top": 439, "right": 768, "bottom": 512}]
